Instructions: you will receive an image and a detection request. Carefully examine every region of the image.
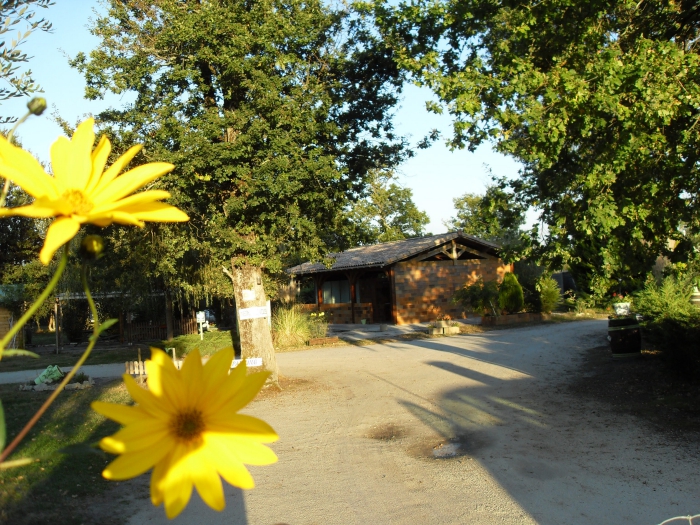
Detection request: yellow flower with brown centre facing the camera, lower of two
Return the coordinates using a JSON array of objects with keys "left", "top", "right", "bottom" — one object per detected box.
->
[{"left": 92, "top": 348, "right": 278, "bottom": 518}]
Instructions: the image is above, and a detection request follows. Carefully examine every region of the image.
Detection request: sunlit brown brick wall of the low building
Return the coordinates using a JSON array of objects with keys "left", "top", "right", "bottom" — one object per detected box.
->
[{"left": 394, "top": 258, "right": 510, "bottom": 324}]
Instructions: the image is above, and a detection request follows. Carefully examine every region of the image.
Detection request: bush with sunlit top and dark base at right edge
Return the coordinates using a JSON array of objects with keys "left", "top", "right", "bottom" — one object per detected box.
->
[{"left": 634, "top": 276, "right": 700, "bottom": 378}]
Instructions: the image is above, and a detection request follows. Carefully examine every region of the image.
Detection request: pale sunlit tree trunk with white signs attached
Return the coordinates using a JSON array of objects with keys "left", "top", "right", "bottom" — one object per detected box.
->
[{"left": 226, "top": 265, "right": 277, "bottom": 384}]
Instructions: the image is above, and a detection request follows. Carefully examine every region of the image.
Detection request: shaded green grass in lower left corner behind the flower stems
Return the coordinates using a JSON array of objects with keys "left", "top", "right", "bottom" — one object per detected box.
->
[{"left": 0, "top": 381, "right": 129, "bottom": 525}]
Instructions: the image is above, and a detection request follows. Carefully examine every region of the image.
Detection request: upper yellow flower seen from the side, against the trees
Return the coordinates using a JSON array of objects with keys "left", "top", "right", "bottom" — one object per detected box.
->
[{"left": 0, "top": 119, "right": 188, "bottom": 264}]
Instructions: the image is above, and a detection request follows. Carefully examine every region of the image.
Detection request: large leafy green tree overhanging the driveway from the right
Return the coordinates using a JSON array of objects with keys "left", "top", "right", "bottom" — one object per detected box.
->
[{"left": 375, "top": 0, "right": 700, "bottom": 295}]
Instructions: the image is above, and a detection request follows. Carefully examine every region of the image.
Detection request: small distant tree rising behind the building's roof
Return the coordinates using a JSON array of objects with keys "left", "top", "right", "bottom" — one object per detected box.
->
[{"left": 343, "top": 170, "right": 430, "bottom": 248}]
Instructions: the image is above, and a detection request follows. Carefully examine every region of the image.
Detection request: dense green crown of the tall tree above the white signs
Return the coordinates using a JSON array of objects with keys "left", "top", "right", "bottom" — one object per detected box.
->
[{"left": 72, "top": 0, "right": 405, "bottom": 378}]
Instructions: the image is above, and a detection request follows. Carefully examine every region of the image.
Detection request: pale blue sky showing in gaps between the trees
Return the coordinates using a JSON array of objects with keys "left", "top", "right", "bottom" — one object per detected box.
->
[{"left": 2, "top": 0, "right": 519, "bottom": 233}]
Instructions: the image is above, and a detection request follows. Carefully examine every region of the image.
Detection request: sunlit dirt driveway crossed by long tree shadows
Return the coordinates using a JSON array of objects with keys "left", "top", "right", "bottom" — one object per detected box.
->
[{"left": 101, "top": 321, "right": 700, "bottom": 525}]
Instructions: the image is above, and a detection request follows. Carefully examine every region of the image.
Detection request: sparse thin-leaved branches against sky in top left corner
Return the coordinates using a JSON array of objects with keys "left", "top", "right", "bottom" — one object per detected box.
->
[{"left": 0, "top": 0, "right": 53, "bottom": 124}]
